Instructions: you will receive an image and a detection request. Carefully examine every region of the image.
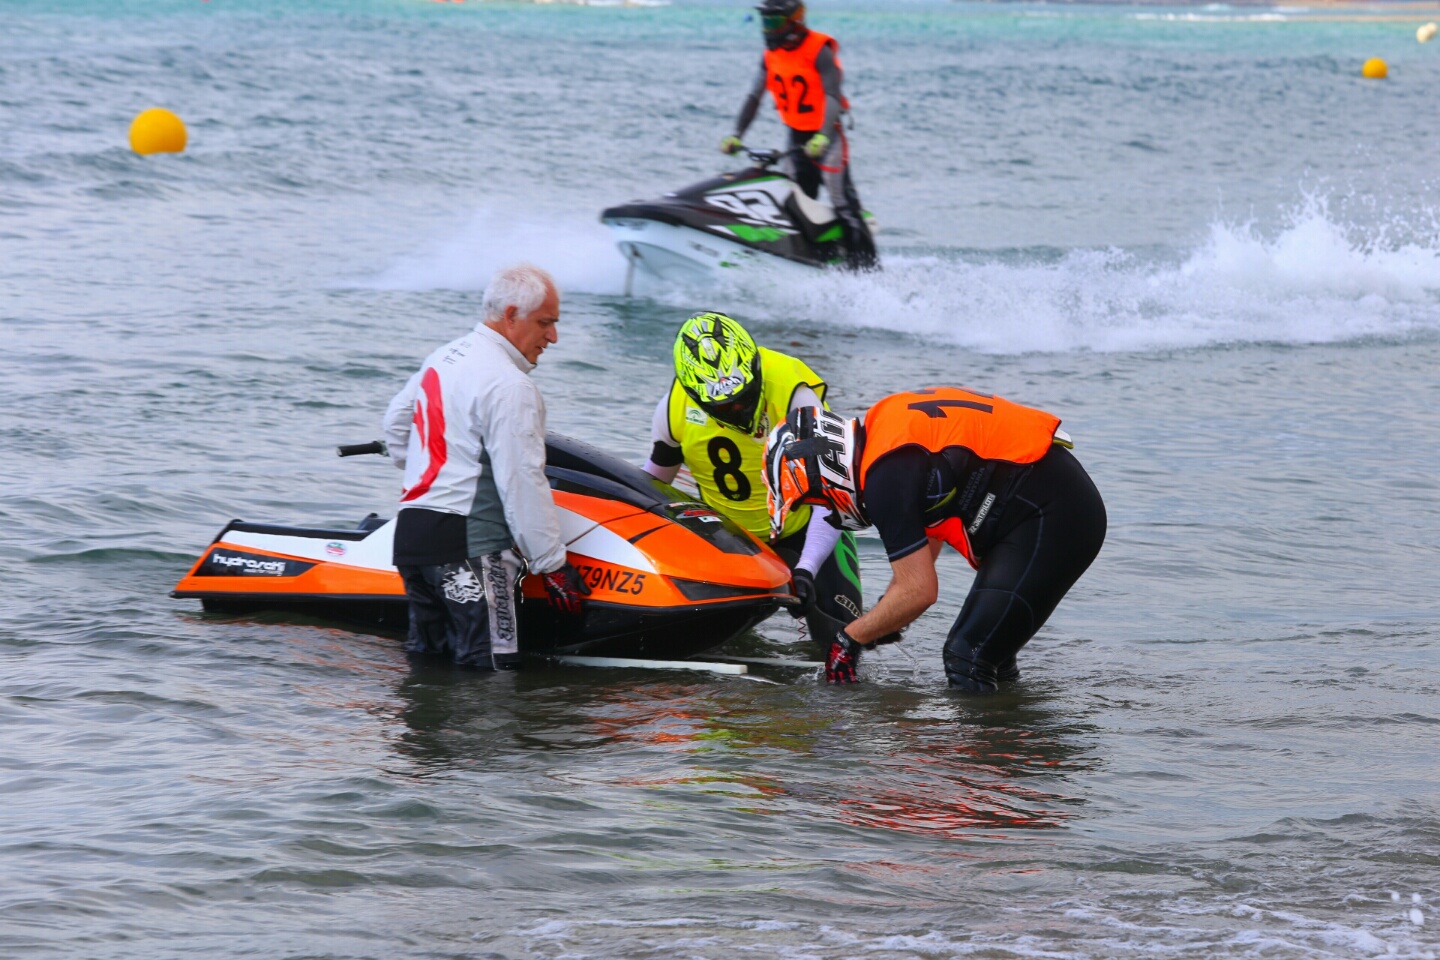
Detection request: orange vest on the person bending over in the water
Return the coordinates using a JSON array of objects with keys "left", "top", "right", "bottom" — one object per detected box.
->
[{"left": 860, "top": 387, "right": 1060, "bottom": 566}]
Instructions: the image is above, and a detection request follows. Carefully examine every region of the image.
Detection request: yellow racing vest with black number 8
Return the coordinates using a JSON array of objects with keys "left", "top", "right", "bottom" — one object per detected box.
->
[{"left": 668, "top": 347, "right": 825, "bottom": 540}]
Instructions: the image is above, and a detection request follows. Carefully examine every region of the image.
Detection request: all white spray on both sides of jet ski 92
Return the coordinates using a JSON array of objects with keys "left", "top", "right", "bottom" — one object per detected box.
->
[{"left": 362, "top": 197, "right": 1440, "bottom": 354}]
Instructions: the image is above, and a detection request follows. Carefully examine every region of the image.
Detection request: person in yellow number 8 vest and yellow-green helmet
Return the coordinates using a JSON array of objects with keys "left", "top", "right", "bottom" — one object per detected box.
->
[{"left": 645, "top": 314, "right": 861, "bottom": 653}]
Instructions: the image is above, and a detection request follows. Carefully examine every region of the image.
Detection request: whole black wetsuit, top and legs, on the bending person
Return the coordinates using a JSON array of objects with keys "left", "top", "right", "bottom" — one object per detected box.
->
[{"left": 864, "top": 445, "right": 1106, "bottom": 691}]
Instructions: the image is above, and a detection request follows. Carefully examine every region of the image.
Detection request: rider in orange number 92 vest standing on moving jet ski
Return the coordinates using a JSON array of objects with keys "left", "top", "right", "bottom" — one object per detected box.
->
[{"left": 720, "top": 0, "right": 880, "bottom": 271}]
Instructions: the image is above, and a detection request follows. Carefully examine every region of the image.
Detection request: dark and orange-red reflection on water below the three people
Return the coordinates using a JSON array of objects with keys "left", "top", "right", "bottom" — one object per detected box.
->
[{"left": 383, "top": 664, "right": 1096, "bottom": 839}]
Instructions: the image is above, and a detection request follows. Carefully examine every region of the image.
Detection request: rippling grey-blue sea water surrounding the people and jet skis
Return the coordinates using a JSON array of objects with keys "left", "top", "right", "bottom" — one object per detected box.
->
[{"left": 0, "top": 0, "right": 1440, "bottom": 960}]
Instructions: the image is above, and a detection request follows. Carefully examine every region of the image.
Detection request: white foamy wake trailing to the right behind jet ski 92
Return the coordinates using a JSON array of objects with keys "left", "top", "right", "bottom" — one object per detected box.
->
[{"left": 711, "top": 197, "right": 1440, "bottom": 354}]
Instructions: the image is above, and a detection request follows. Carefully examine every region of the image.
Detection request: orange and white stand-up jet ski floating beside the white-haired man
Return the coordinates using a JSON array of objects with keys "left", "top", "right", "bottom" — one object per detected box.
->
[{"left": 171, "top": 433, "right": 792, "bottom": 659}]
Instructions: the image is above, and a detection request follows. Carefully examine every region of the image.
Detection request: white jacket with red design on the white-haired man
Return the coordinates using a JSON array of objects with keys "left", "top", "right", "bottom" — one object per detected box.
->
[{"left": 384, "top": 324, "right": 564, "bottom": 573}]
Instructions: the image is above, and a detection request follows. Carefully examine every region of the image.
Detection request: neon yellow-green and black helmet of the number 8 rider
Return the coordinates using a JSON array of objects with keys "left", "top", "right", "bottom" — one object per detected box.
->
[{"left": 675, "top": 314, "right": 765, "bottom": 430}]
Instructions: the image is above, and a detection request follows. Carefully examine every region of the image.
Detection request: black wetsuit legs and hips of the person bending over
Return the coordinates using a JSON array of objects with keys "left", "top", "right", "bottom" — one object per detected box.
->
[{"left": 945, "top": 446, "right": 1106, "bottom": 692}]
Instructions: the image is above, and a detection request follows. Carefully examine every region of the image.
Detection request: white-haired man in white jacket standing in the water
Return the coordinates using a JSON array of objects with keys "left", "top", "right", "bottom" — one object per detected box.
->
[{"left": 384, "top": 265, "right": 589, "bottom": 669}]
